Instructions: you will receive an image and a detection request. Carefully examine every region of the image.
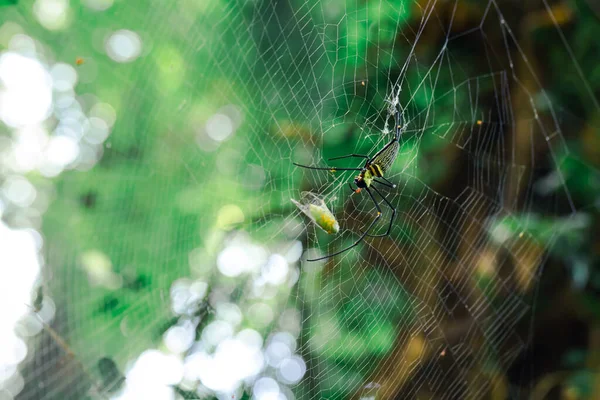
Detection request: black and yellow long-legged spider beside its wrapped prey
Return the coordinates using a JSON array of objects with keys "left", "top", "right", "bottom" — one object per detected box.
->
[{"left": 293, "top": 97, "right": 404, "bottom": 261}]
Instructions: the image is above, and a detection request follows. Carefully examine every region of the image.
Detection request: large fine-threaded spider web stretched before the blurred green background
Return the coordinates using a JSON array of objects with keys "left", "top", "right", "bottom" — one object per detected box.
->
[{"left": 3, "top": 0, "right": 598, "bottom": 399}]
